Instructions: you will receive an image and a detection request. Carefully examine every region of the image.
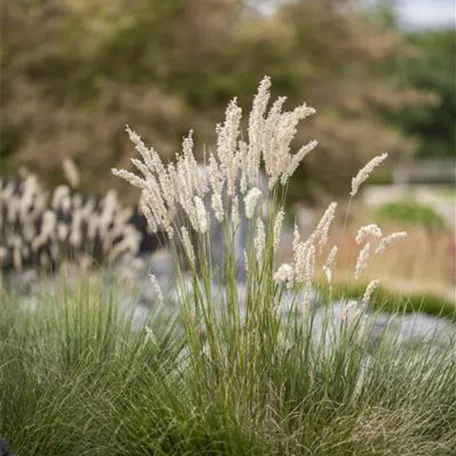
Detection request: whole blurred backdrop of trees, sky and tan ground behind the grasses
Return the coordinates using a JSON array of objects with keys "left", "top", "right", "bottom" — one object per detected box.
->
[{"left": 0, "top": 0, "right": 456, "bottom": 299}]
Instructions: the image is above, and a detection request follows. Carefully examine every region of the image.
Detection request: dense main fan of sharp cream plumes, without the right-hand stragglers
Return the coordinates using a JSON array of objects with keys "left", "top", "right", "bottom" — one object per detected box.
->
[{"left": 112, "top": 77, "right": 317, "bottom": 242}]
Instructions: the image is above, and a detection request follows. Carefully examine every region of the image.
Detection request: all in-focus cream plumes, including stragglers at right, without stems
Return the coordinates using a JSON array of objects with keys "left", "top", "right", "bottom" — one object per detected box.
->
[{"left": 112, "top": 77, "right": 403, "bottom": 314}]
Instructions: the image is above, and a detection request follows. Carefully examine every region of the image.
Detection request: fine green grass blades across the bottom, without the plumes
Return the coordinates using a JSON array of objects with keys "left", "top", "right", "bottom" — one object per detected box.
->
[{"left": 0, "top": 284, "right": 456, "bottom": 456}]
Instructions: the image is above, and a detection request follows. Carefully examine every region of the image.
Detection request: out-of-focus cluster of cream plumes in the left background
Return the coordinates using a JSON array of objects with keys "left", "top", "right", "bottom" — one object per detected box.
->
[{"left": 0, "top": 171, "right": 158, "bottom": 273}]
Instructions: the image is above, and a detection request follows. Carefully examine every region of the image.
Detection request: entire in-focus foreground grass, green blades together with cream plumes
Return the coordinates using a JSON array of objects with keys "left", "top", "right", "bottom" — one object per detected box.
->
[{"left": 0, "top": 78, "right": 456, "bottom": 456}]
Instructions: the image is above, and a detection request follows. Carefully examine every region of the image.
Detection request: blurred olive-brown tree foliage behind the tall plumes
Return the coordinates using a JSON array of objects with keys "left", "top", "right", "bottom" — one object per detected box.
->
[{"left": 0, "top": 0, "right": 442, "bottom": 198}]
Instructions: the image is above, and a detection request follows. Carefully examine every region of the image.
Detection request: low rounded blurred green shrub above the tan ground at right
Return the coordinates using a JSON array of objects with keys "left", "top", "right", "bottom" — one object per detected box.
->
[{"left": 374, "top": 200, "right": 448, "bottom": 231}]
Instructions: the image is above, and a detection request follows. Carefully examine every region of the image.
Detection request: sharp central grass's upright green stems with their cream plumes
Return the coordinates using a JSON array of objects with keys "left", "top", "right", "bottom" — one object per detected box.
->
[{"left": 112, "top": 77, "right": 414, "bottom": 380}]
